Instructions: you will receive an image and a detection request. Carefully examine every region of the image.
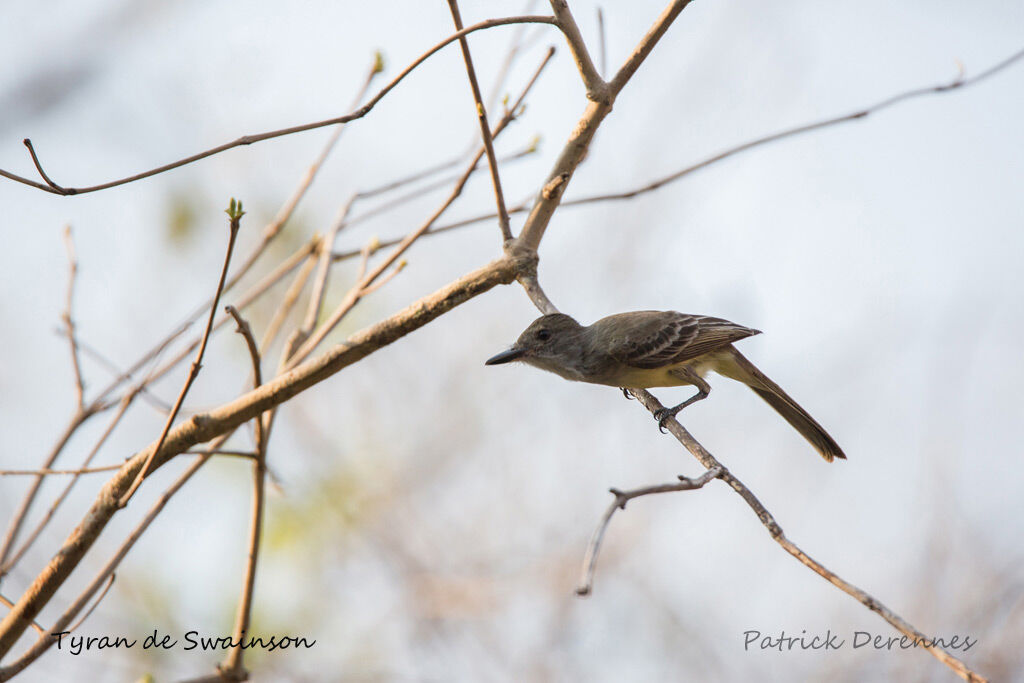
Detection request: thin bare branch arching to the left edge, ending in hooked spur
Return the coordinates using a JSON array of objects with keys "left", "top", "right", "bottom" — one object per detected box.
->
[{"left": 0, "top": 16, "right": 555, "bottom": 196}]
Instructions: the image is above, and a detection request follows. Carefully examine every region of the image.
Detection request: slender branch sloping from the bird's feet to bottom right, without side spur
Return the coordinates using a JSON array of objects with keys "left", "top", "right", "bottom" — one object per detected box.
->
[{"left": 630, "top": 389, "right": 985, "bottom": 681}]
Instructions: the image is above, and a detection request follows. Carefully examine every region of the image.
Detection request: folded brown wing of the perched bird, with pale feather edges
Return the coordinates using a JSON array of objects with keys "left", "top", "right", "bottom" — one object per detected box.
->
[{"left": 594, "top": 310, "right": 759, "bottom": 369}]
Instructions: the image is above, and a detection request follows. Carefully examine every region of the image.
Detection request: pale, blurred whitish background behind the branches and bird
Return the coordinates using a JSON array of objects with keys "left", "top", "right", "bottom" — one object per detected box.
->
[{"left": 0, "top": 0, "right": 1024, "bottom": 681}]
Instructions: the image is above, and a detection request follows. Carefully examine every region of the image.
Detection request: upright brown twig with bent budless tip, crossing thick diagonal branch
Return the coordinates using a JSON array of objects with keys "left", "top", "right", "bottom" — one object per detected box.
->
[{"left": 217, "top": 309, "right": 268, "bottom": 680}]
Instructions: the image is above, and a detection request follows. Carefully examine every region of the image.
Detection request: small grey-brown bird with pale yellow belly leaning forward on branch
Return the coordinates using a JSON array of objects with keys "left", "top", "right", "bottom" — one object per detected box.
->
[{"left": 486, "top": 310, "right": 846, "bottom": 462}]
